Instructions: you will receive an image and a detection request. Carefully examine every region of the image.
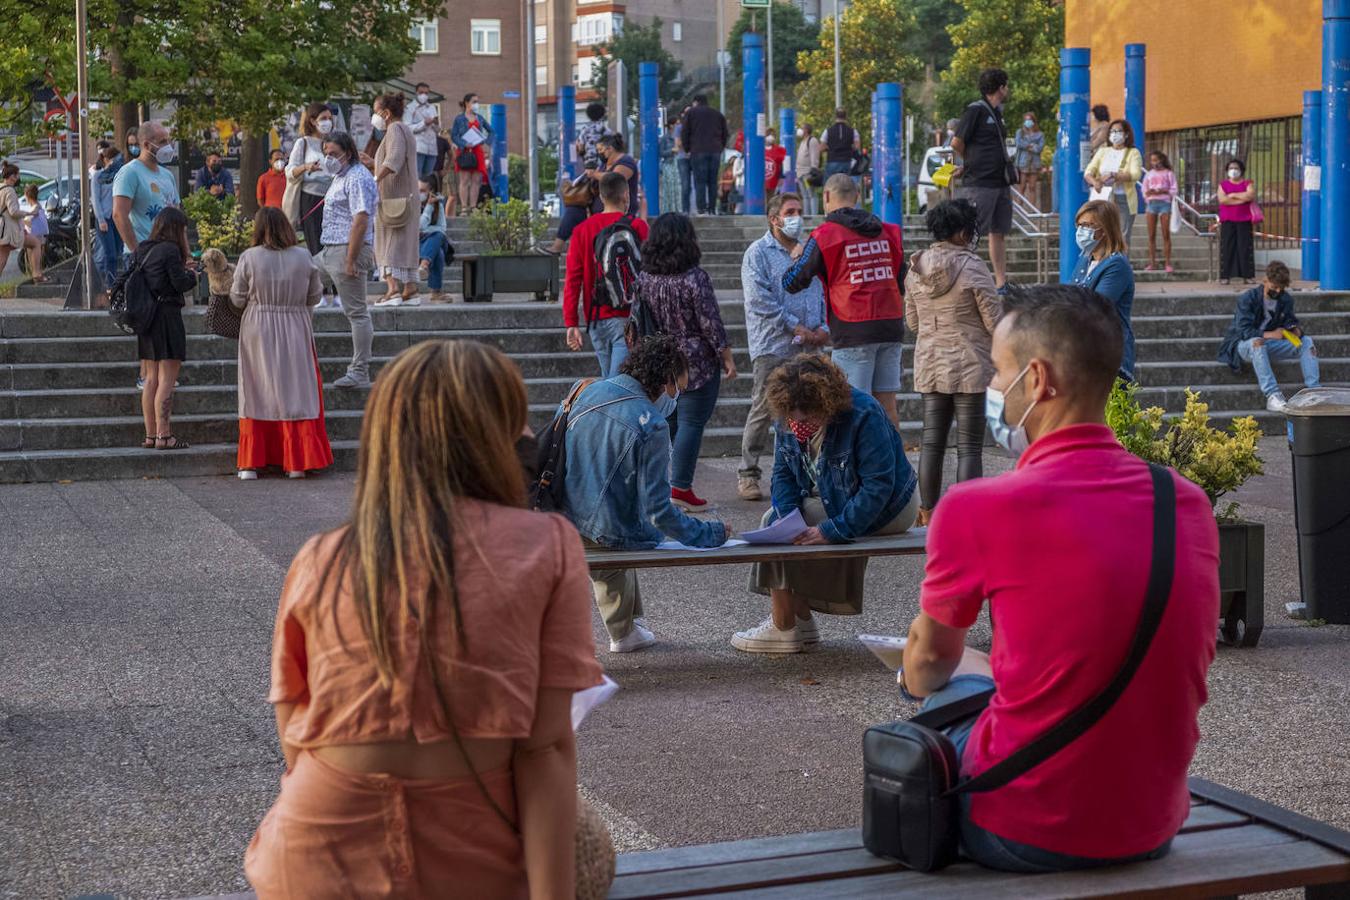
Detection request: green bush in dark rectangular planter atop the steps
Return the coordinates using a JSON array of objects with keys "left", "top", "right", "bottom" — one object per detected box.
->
[{"left": 463, "top": 200, "right": 562, "bottom": 302}]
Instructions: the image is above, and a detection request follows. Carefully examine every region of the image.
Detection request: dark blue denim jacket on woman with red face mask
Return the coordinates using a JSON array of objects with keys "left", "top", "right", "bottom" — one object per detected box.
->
[{"left": 772, "top": 389, "right": 918, "bottom": 544}]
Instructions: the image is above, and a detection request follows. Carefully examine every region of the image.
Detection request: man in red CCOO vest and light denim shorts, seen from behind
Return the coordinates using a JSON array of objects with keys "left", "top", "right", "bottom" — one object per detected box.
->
[{"left": 783, "top": 173, "right": 905, "bottom": 425}]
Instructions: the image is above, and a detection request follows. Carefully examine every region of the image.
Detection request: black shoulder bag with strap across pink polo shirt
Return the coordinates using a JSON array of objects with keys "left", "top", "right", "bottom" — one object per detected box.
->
[{"left": 863, "top": 464, "right": 1176, "bottom": 872}]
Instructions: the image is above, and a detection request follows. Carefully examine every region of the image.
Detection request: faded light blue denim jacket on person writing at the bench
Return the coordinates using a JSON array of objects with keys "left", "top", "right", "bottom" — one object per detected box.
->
[{"left": 563, "top": 375, "right": 726, "bottom": 551}]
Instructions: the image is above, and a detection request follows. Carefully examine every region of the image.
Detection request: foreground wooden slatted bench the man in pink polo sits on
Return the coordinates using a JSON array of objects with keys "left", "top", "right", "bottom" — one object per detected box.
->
[{"left": 610, "top": 779, "right": 1350, "bottom": 900}]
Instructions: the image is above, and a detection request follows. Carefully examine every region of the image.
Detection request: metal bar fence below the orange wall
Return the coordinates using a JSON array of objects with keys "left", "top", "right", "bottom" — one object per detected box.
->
[{"left": 1143, "top": 116, "right": 1303, "bottom": 250}]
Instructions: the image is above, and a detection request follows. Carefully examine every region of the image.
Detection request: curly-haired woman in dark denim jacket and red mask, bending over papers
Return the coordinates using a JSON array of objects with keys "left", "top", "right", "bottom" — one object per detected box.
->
[{"left": 732, "top": 355, "right": 918, "bottom": 653}]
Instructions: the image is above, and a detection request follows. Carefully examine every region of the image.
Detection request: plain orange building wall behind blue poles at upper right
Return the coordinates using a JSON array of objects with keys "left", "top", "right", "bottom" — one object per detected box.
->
[{"left": 1069, "top": 0, "right": 1322, "bottom": 131}]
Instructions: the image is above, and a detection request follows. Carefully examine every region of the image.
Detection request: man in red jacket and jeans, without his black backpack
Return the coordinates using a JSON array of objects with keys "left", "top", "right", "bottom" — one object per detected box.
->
[{"left": 563, "top": 171, "right": 647, "bottom": 378}]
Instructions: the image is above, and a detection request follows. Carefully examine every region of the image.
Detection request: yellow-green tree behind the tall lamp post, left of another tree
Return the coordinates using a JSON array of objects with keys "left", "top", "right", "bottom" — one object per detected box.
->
[{"left": 797, "top": 0, "right": 923, "bottom": 144}]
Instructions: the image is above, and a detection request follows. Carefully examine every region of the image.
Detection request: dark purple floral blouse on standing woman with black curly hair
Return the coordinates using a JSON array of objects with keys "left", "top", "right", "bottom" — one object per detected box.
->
[{"left": 637, "top": 266, "right": 728, "bottom": 390}]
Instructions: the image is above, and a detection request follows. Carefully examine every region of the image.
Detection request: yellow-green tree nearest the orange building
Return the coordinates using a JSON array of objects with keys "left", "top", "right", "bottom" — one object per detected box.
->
[{"left": 938, "top": 0, "right": 1064, "bottom": 131}]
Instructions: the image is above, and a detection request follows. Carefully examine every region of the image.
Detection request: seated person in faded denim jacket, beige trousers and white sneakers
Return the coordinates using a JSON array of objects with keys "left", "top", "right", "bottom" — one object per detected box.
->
[{"left": 563, "top": 335, "right": 728, "bottom": 653}]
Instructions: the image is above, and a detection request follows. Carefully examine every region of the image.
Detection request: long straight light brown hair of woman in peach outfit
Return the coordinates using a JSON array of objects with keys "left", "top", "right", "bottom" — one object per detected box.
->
[{"left": 320, "top": 340, "right": 527, "bottom": 687}]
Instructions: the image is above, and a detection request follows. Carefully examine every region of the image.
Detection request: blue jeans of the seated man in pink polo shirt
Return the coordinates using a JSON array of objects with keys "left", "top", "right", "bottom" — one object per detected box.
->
[{"left": 919, "top": 675, "right": 1172, "bottom": 874}]
